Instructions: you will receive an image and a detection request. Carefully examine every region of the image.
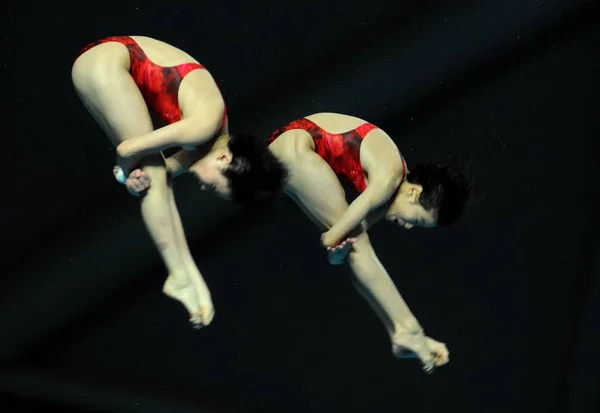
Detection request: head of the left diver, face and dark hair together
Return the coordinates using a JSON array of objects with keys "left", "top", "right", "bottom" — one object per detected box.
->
[{"left": 190, "top": 135, "right": 287, "bottom": 206}]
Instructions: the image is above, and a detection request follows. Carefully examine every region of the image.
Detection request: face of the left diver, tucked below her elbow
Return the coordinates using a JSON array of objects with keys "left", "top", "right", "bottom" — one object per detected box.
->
[{"left": 190, "top": 149, "right": 231, "bottom": 199}]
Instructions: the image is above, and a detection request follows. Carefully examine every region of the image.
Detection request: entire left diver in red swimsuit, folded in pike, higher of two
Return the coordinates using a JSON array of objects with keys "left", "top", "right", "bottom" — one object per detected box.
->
[{"left": 72, "top": 36, "right": 285, "bottom": 327}]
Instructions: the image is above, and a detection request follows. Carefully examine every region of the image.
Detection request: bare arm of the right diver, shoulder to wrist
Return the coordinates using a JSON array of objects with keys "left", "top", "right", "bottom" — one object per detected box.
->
[{"left": 321, "top": 131, "right": 403, "bottom": 247}]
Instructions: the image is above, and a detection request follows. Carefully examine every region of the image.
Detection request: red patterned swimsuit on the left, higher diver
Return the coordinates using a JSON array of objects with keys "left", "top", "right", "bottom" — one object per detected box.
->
[{"left": 77, "top": 36, "right": 227, "bottom": 126}]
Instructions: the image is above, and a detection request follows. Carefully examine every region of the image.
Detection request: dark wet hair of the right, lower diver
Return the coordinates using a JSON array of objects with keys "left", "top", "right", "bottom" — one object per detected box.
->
[{"left": 406, "top": 162, "right": 471, "bottom": 226}]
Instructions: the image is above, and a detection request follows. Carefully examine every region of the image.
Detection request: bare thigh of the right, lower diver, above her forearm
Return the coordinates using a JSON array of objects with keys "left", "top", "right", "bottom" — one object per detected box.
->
[{"left": 286, "top": 149, "right": 348, "bottom": 230}]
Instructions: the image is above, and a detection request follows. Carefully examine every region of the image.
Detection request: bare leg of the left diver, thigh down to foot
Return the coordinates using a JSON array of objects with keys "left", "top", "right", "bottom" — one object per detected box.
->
[{"left": 72, "top": 47, "right": 212, "bottom": 324}]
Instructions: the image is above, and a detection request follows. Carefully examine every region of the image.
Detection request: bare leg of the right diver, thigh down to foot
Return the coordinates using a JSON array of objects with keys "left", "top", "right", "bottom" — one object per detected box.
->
[{"left": 286, "top": 150, "right": 443, "bottom": 369}]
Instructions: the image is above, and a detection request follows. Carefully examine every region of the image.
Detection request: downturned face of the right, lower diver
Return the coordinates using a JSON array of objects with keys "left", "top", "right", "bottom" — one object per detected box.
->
[{"left": 385, "top": 181, "right": 435, "bottom": 229}]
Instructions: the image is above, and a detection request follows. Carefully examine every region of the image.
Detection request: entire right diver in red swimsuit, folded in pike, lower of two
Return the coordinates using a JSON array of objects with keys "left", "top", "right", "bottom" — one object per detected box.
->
[{"left": 122, "top": 113, "right": 471, "bottom": 372}]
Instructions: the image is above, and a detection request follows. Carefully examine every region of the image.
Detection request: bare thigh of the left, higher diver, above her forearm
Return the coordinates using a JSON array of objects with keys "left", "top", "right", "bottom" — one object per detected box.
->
[{"left": 71, "top": 42, "right": 153, "bottom": 146}]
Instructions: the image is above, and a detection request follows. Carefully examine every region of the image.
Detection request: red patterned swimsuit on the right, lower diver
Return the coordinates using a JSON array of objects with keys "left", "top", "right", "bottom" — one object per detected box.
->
[{"left": 268, "top": 118, "right": 406, "bottom": 192}]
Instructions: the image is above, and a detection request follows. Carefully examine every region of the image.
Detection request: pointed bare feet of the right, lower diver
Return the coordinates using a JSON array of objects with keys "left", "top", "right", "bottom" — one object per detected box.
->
[{"left": 392, "top": 332, "right": 450, "bottom": 373}]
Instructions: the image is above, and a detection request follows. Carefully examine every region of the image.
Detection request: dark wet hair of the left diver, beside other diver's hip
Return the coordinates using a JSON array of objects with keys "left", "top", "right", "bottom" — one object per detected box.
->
[{"left": 223, "top": 135, "right": 287, "bottom": 206}]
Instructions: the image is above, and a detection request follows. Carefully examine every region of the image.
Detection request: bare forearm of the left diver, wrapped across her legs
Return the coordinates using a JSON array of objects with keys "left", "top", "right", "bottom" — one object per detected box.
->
[{"left": 117, "top": 105, "right": 224, "bottom": 159}]
